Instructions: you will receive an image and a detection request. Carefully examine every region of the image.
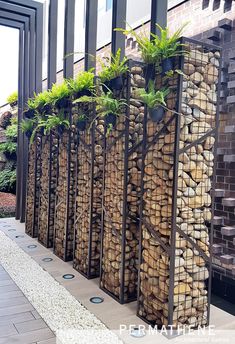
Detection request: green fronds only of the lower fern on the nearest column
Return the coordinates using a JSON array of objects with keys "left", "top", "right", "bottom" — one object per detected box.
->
[{"left": 139, "top": 80, "right": 170, "bottom": 109}]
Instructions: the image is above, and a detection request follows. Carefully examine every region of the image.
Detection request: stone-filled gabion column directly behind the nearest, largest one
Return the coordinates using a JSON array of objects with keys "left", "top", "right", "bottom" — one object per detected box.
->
[{"left": 100, "top": 62, "right": 145, "bottom": 303}]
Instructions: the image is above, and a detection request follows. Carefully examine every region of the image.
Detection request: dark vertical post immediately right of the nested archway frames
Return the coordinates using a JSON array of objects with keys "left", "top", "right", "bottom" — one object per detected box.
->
[{"left": 47, "top": 0, "right": 58, "bottom": 89}]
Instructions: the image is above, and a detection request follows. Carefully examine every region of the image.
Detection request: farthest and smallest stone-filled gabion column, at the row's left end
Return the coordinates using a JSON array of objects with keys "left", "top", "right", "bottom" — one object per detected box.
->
[{"left": 25, "top": 134, "right": 41, "bottom": 238}]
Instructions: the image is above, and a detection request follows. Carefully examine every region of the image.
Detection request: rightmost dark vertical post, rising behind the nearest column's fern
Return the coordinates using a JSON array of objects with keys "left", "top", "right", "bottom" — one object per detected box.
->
[{"left": 150, "top": 0, "right": 168, "bottom": 39}]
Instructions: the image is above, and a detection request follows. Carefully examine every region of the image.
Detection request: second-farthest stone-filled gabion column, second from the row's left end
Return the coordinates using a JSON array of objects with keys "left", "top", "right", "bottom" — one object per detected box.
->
[{"left": 38, "top": 133, "right": 58, "bottom": 247}]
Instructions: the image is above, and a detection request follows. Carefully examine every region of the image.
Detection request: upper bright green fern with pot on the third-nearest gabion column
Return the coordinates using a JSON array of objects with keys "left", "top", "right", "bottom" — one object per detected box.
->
[{"left": 67, "top": 68, "right": 95, "bottom": 98}]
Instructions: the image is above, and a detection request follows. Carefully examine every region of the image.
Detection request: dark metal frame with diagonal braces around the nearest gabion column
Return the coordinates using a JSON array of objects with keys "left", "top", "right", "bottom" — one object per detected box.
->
[{"left": 137, "top": 37, "right": 221, "bottom": 325}]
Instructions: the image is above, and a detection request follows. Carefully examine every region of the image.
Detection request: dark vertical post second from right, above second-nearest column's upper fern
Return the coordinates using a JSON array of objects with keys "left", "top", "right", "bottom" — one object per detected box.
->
[{"left": 111, "top": 0, "right": 127, "bottom": 57}]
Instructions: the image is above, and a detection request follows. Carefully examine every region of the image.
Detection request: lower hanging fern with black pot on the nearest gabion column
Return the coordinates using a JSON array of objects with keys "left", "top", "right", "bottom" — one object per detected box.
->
[{"left": 139, "top": 80, "right": 170, "bottom": 123}]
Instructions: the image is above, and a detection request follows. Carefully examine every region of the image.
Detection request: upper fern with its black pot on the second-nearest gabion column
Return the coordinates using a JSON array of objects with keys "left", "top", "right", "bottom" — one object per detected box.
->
[{"left": 98, "top": 48, "right": 128, "bottom": 92}]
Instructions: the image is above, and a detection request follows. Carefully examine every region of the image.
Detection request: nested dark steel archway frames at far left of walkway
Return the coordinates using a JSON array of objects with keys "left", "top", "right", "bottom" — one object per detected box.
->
[{"left": 0, "top": 0, "right": 43, "bottom": 222}]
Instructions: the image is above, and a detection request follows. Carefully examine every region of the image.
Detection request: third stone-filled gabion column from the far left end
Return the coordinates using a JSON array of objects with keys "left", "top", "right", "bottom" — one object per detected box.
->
[{"left": 53, "top": 109, "right": 77, "bottom": 261}]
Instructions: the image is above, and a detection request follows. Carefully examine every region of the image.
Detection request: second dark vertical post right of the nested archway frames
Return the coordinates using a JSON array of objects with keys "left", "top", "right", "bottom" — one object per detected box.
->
[{"left": 63, "top": 0, "right": 75, "bottom": 78}]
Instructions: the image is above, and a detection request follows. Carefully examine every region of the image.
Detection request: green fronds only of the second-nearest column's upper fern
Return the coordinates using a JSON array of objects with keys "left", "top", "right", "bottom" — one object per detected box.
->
[{"left": 98, "top": 48, "right": 128, "bottom": 83}]
